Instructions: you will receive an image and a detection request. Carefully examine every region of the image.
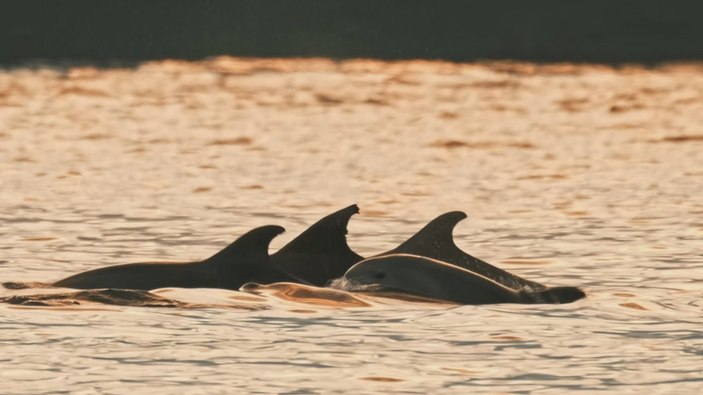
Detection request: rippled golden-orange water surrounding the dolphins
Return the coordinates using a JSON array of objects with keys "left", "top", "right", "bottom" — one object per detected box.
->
[{"left": 0, "top": 58, "right": 703, "bottom": 394}]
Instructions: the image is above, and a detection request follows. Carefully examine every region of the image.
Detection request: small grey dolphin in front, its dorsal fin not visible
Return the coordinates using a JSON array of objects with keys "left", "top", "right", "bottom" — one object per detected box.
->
[{"left": 344, "top": 254, "right": 586, "bottom": 305}]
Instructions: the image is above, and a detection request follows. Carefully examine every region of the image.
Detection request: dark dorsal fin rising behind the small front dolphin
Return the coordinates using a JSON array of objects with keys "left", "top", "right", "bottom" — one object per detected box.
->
[{"left": 383, "top": 211, "right": 467, "bottom": 259}]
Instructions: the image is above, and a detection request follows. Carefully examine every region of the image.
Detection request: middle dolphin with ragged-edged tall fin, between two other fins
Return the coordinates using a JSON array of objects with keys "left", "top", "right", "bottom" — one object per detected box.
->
[{"left": 271, "top": 204, "right": 363, "bottom": 286}]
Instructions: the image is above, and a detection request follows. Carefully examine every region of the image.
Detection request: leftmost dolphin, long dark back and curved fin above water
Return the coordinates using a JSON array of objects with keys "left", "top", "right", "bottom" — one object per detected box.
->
[{"left": 53, "top": 225, "right": 294, "bottom": 290}]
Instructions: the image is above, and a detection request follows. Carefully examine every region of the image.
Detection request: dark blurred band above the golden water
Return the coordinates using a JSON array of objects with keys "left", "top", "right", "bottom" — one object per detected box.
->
[{"left": 0, "top": 0, "right": 703, "bottom": 64}]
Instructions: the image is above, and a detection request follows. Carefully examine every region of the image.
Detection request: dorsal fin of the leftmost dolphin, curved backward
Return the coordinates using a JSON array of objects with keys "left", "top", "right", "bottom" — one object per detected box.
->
[{"left": 204, "top": 225, "right": 285, "bottom": 265}]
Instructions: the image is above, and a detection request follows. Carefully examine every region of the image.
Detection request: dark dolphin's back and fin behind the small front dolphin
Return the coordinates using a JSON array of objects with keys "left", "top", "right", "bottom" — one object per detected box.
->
[{"left": 379, "top": 211, "right": 545, "bottom": 290}]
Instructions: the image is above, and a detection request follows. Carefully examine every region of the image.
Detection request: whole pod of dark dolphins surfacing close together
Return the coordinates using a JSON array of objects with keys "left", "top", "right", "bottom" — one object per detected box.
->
[{"left": 53, "top": 205, "right": 585, "bottom": 304}]
